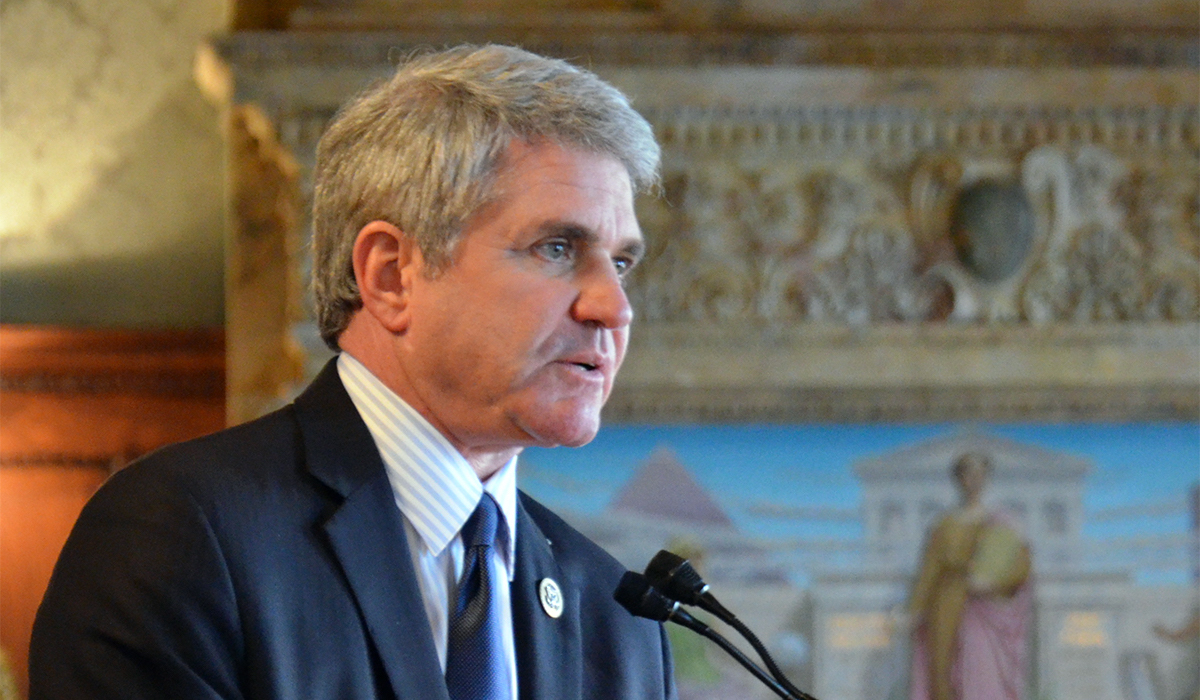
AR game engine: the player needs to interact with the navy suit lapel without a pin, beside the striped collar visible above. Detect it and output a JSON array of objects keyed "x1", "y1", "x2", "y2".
[{"x1": 295, "y1": 361, "x2": 449, "y2": 700}]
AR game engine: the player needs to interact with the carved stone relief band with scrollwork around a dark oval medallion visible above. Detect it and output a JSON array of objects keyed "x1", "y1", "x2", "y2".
[{"x1": 631, "y1": 112, "x2": 1200, "y2": 325}]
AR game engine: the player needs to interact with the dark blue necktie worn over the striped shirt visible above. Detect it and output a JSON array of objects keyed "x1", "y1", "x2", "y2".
[{"x1": 446, "y1": 492, "x2": 508, "y2": 700}]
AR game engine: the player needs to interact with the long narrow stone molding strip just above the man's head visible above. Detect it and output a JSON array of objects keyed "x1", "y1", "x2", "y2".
[{"x1": 215, "y1": 26, "x2": 1200, "y2": 73}]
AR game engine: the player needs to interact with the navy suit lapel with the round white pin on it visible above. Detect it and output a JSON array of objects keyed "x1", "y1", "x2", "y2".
[{"x1": 512, "y1": 498, "x2": 583, "y2": 700}]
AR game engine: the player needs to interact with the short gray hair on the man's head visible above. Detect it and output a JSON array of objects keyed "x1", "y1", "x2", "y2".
[{"x1": 312, "y1": 46, "x2": 660, "y2": 349}]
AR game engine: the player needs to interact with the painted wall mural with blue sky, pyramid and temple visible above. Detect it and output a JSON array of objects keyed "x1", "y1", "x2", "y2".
[{"x1": 521, "y1": 423, "x2": 1200, "y2": 700}]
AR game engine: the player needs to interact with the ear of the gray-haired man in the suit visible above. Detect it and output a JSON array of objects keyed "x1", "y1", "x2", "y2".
[{"x1": 354, "y1": 221, "x2": 421, "y2": 333}]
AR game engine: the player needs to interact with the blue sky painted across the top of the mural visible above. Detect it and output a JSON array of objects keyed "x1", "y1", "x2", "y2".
[{"x1": 521, "y1": 423, "x2": 1200, "y2": 585}]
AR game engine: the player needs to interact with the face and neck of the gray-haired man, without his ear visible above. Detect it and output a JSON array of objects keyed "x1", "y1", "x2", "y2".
[{"x1": 400, "y1": 142, "x2": 643, "y2": 450}]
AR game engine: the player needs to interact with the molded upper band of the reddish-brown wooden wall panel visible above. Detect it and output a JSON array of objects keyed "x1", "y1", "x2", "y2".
[{"x1": 0, "y1": 325, "x2": 226, "y2": 469}]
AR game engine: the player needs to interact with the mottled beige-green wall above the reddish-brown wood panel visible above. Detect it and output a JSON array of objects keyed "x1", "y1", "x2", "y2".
[{"x1": 0, "y1": 0, "x2": 227, "y2": 327}]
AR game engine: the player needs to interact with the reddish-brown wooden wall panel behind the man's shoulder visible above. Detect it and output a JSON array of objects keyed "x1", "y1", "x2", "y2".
[{"x1": 0, "y1": 325, "x2": 224, "y2": 694}]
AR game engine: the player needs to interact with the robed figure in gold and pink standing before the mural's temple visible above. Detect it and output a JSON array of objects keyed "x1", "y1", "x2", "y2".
[{"x1": 907, "y1": 453, "x2": 1032, "y2": 700}]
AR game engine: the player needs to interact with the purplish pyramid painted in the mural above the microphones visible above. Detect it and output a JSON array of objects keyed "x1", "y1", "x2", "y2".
[{"x1": 608, "y1": 447, "x2": 733, "y2": 528}]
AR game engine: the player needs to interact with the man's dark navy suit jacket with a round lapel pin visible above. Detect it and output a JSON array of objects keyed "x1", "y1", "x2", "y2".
[{"x1": 30, "y1": 363, "x2": 674, "y2": 700}]
